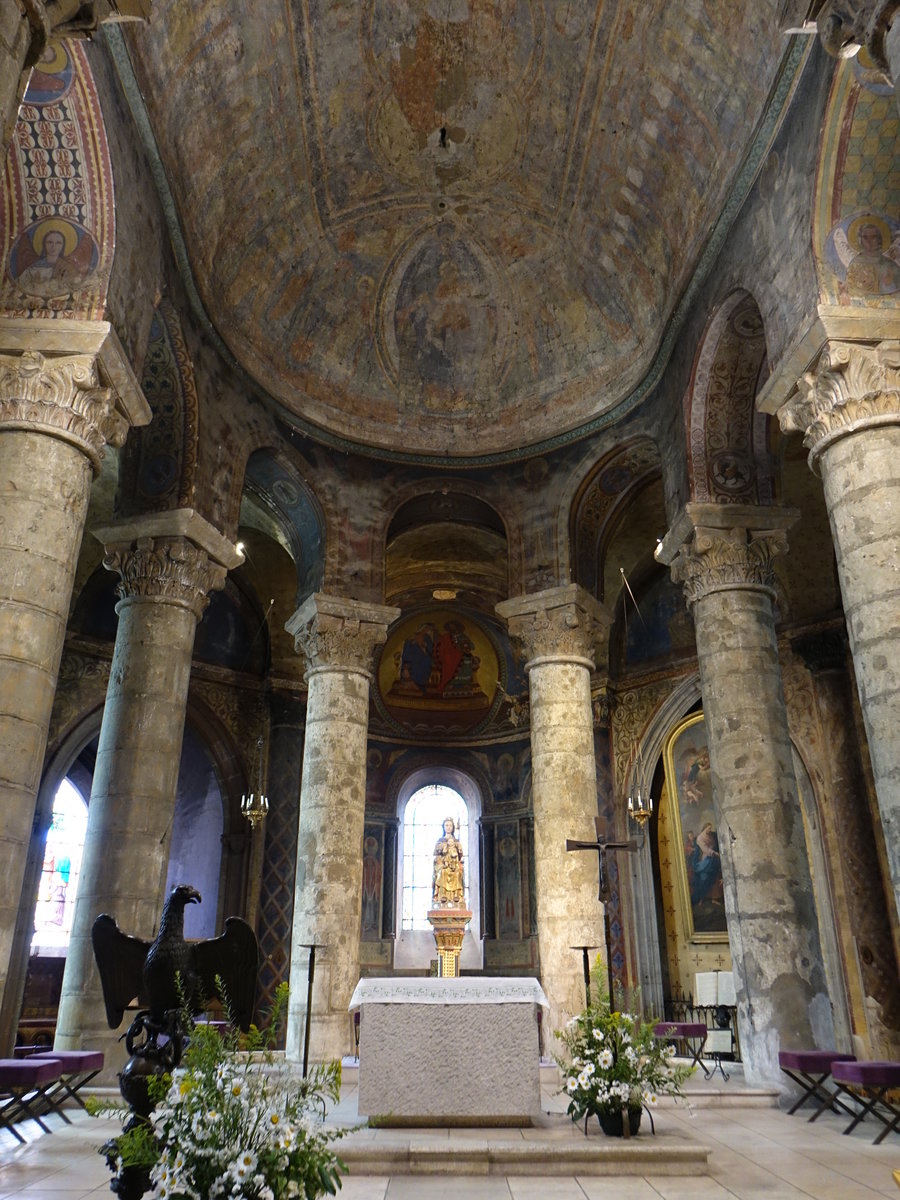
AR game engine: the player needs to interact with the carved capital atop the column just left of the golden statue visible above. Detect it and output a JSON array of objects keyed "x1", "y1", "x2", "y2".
[{"x1": 284, "y1": 592, "x2": 401, "y2": 678}]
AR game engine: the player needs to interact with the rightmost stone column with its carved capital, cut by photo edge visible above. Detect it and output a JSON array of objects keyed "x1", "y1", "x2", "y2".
[{"x1": 778, "y1": 341, "x2": 900, "y2": 931}]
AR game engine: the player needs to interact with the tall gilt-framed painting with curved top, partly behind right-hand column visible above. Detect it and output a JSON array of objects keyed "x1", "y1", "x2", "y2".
[{"x1": 665, "y1": 713, "x2": 728, "y2": 942}]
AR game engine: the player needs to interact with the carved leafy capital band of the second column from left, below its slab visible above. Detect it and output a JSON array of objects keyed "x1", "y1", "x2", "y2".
[{"x1": 103, "y1": 538, "x2": 227, "y2": 620}]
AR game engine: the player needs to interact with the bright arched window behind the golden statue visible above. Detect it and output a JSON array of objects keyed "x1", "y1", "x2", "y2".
[{"x1": 401, "y1": 784, "x2": 473, "y2": 929}]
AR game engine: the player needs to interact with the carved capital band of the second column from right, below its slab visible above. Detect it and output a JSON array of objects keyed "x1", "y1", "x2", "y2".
[{"x1": 671, "y1": 526, "x2": 787, "y2": 605}]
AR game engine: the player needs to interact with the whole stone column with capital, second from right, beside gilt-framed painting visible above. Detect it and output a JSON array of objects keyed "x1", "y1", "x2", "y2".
[{"x1": 656, "y1": 504, "x2": 834, "y2": 1086}]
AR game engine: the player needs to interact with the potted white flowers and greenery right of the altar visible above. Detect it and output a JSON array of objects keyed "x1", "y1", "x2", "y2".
[{"x1": 557, "y1": 974, "x2": 694, "y2": 1138}]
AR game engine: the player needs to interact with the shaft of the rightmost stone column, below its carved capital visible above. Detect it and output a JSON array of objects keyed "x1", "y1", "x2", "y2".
[{"x1": 820, "y1": 424, "x2": 900, "y2": 916}]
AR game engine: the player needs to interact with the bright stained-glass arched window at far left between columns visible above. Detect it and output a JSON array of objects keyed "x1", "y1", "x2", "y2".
[{"x1": 31, "y1": 779, "x2": 88, "y2": 954}]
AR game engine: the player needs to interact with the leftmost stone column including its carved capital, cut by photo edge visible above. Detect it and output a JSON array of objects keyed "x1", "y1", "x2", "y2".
[{"x1": 0, "y1": 322, "x2": 150, "y2": 1050}]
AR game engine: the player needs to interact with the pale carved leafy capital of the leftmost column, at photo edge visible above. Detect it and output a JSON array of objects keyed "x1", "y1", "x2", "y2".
[{"x1": 0, "y1": 352, "x2": 128, "y2": 473}]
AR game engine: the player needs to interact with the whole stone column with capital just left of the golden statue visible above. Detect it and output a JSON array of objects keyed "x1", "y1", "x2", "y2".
[{"x1": 286, "y1": 593, "x2": 400, "y2": 1062}]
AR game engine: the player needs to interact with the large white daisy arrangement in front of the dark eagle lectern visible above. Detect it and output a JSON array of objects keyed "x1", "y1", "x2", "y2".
[{"x1": 95, "y1": 988, "x2": 344, "y2": 1200}]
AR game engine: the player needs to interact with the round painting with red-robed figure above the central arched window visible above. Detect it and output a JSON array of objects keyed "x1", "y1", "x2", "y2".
[{"x1": 376, "y1": 608, "x2": 503, "y2": 733}]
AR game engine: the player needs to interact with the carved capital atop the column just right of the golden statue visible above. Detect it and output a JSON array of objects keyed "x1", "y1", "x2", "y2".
[{"x1": 496, "y1": 583, "x2": 611, "y2": 670}]
